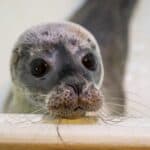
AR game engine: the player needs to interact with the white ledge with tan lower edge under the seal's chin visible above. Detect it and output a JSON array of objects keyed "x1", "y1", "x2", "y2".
[{"x1": 0, "y1": 114, "x2": 150, "y2": 150}]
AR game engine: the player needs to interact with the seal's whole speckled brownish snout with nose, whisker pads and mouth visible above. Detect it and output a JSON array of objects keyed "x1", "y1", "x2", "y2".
[{"x1": 48, "y1": 81, "x2": 103, "y2": 118}]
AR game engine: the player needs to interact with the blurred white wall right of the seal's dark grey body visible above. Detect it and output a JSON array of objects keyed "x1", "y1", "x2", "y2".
[{"x1": 125, "y1": 0, "x2": 150, "y2": 117}]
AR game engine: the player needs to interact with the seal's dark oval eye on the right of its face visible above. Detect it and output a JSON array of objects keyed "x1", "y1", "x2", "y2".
[{"x1": 82, "y1": 53, "x2": 97, "y2": 71}]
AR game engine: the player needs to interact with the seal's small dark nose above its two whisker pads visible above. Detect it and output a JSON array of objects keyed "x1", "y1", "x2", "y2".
[{"x1": 68, "y1": 81, "x2": 84, "y2": 95}]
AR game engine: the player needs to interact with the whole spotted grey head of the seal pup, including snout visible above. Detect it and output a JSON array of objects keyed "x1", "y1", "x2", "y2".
[{"x1": 11, "y1": 23, "x2": 103, "y2": 118}]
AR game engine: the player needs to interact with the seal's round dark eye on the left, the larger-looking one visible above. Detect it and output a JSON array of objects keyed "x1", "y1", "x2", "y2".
[{"x1": 30, "y1": 58, "x2": 49, "y2": 77}]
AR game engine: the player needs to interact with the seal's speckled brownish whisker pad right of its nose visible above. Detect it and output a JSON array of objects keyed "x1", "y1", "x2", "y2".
[{"x1": 79, "y1": 86, "x2": 104, "y2": 111}]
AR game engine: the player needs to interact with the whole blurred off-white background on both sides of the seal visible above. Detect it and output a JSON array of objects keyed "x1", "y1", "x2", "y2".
[{"x1": 0, "y1": 0, "x2": 150, "y2": 116}]
